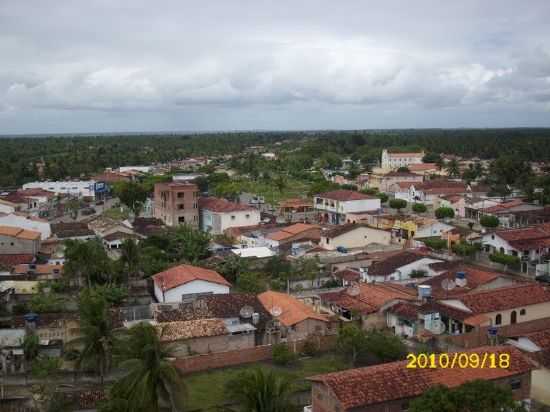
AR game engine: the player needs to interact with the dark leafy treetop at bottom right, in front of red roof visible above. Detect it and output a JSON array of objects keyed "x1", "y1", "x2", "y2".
[{"x1": 409, "y1": 380, "x2": 525, "y2": 412}]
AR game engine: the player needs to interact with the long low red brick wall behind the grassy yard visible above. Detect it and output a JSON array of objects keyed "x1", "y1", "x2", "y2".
[{"x1": 174, "y1": 336, "x2": 336, "y2": 373}]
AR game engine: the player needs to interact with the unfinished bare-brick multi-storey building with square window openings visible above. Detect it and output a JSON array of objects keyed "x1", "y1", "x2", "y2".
[{"x1": 153, "y1": 182, "x2": 199, "y2": 228}]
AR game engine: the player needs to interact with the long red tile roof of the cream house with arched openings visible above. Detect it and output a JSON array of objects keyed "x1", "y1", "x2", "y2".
[{"x1": 440, "y1": 283, "x2": 550, "y2": 315}]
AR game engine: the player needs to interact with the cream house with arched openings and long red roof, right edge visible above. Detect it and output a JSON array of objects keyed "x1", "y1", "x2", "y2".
[{"x1": 433, "y1": 282, "x2": 550, "y2": 334}]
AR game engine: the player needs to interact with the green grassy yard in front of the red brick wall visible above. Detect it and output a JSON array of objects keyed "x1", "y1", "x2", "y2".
[{"x1": 185, "y1": 353, "x2": 351, "y2": 411}]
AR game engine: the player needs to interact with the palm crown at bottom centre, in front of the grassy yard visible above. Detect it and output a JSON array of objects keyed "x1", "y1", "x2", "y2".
[{"x1": 227, "y1": 368, "x2": 295, "y2": 412}]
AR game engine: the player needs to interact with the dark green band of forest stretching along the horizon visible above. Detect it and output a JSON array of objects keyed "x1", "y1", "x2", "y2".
[{"x1": 0, "y1": 128, "x2": 550, "y2": 187}]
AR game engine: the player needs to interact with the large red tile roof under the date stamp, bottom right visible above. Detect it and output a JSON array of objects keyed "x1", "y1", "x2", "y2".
[{"x1": 309, "y1": 346, "x2": 533, "y2": 410}]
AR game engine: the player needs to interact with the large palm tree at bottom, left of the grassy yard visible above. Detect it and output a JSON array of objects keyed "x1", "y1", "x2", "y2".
[{"x1": 111, "y1": 323, "x2": 186, "y2": 412}]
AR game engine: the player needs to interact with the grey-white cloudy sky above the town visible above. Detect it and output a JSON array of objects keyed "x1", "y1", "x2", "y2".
[{"x1": 0, "y1": 0, "x2": 550, "y2": 134}]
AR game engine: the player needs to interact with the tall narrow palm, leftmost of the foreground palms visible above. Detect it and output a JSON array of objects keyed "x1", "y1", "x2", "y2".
[{"x1": 71, "y1": 289, "x2": 115, "y2": 384}]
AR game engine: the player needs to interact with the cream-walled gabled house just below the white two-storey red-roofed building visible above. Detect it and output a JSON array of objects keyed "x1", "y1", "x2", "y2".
[{"x1": 319, "y1": 223, "x2": 392, "y2": 250}]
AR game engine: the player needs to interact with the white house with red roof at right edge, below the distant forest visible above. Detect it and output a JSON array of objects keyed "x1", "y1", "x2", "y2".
[{"x1": 481, "y1": 223, "x2": 550, "y2": 272}]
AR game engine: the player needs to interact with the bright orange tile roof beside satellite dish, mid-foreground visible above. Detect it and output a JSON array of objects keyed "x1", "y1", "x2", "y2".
[{"x1": 258, "y1": 291, "x2": 329, "y2": 326}]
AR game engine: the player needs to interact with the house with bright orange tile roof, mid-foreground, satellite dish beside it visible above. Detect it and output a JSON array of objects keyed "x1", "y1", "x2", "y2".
[{"x1": 258, "y1": 291, "x2": 334, "y2": 343}]
